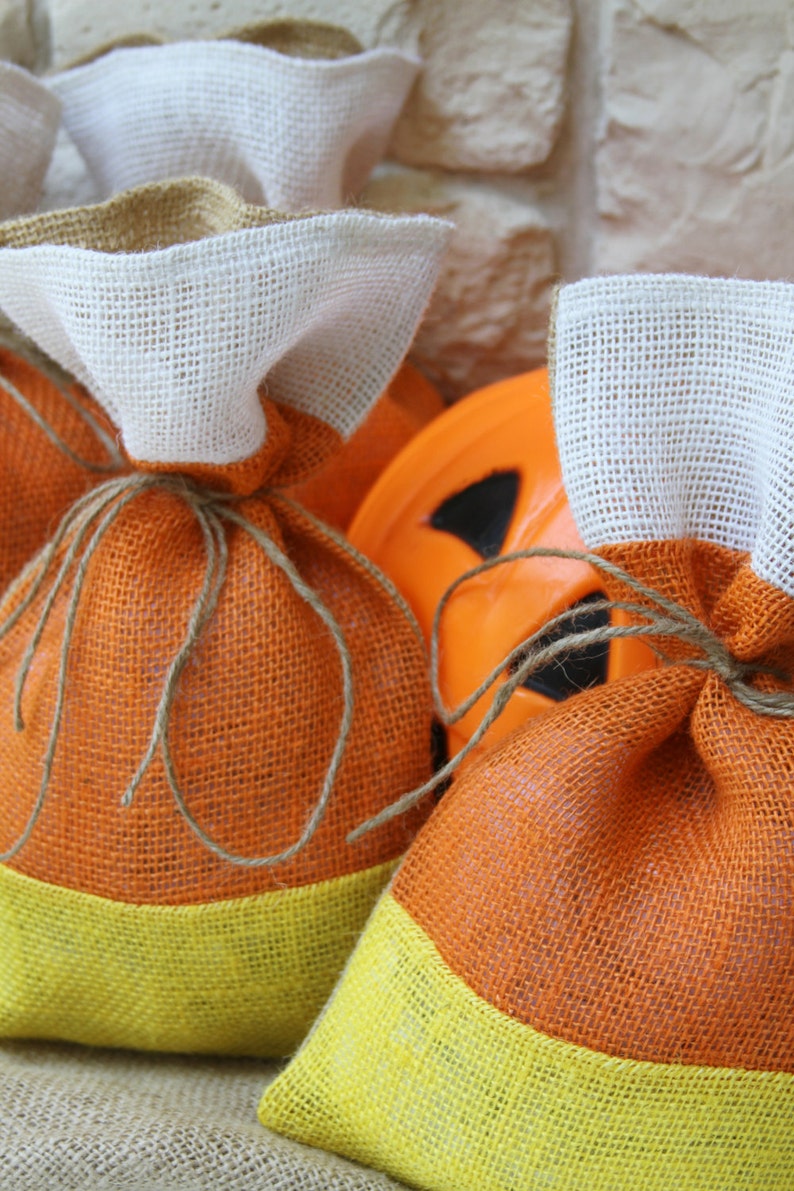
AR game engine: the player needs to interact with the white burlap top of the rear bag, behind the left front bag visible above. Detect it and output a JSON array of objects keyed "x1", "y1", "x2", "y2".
[{"x1": 49, "y1": 42, "x2": 419, "y2": 211}]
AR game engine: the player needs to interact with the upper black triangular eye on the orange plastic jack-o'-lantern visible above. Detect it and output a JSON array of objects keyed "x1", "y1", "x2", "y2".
[{"x1": 430, "y1": 472, "x2": 520, "y2": 559}]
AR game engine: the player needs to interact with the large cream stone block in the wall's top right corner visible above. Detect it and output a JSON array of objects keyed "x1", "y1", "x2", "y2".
[{"x1": 593, "y1": 0, "x2": 794, "y2": 278}]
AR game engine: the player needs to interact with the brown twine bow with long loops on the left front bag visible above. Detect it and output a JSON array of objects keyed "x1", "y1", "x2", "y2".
[{"x1": 0, "y1": 474, "x2": 424, "y2": 868}]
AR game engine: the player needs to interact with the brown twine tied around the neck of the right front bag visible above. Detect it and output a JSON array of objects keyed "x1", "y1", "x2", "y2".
[{"x1": 348, "y1": 545, "x2": 794, "y2": 843}]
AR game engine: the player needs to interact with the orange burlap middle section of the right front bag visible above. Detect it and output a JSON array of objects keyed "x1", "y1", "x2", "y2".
[{"x1": 393, "y1": 541, "x2": 794, "y2": 1072}]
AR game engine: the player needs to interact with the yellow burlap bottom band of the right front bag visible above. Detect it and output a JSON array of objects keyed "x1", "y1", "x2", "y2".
[{"x1": 260, "y1": 894, "x2": 794, "y2": 1191}]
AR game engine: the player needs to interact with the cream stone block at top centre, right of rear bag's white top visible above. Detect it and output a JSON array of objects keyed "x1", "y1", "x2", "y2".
[{"x1": 393, "y1": 0, "x2": 571, "y2": 174}]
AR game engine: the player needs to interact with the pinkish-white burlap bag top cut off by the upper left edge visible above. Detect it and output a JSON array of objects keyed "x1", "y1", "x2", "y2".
[{"x1": 0, "y1": 62, "x2": 61, "y2": 219}]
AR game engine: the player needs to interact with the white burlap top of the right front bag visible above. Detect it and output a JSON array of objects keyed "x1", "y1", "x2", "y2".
[{"x1": 554, "y1": 275, "x2": 794, "y2": 596}]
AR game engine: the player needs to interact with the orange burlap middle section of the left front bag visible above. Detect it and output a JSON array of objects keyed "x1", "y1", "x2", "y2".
[{"x1": 0, "y1": 403, "x2": 431, "y2": 905}]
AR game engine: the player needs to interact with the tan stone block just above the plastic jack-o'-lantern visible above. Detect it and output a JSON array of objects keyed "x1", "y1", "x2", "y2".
[{"x1": 362, "y1": 168, "x2": 556, "y2": 398}]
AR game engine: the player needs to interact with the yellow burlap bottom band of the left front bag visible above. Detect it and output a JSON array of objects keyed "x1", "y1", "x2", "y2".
[{"x1": 0, "y1": 862, "x2": 394, "y2": 1056}]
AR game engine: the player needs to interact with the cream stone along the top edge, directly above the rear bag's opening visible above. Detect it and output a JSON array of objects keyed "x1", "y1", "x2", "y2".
[{"x1": 49, "y1": 0, "x2": 415, "y2": 69}]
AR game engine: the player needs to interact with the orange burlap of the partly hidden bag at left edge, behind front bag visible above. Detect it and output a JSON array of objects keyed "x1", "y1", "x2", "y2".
[{"x1": 0, "y1": 348, "x2": 121, "y2": 592}]
